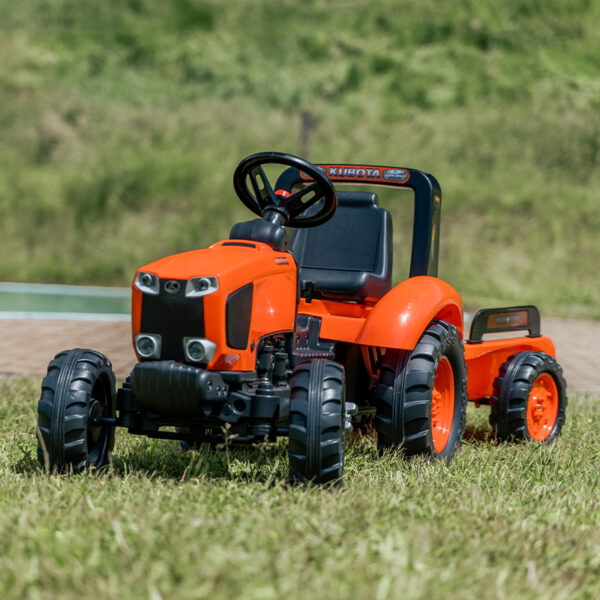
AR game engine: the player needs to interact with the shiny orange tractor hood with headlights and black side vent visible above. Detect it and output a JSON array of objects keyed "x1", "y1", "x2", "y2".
[{"x1": 132, "y1": 240, "x2": 297, "y2": 371}]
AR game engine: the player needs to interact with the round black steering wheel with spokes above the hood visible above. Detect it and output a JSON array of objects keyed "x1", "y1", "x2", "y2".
[{"x1": 233, "y1": 152, "x2": 337, "y2": 227}]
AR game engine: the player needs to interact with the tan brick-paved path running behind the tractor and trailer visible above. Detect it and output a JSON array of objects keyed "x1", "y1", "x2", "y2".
[{"x1": 0, "y1": 317, "x2": 600, "y2": 396}]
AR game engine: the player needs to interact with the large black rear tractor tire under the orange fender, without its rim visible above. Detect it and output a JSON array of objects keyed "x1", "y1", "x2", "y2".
[{"x1": 375, "y1": 321, "x2": 467, "y2": 458}]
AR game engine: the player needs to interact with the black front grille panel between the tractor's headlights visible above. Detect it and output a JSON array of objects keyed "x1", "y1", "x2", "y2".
[{"x1": 141, "y1": 279, "x2": 205, "y2": 361}]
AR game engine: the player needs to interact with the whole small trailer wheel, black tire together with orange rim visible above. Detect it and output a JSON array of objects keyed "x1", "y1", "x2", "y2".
[{"x1": 490, "y1": 351, "x2": 567, "y2": 442}]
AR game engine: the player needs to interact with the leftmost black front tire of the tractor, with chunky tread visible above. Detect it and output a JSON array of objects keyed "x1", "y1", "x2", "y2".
[{"x1": 38, "y1": 348, "x2": 116, "y2": 472}]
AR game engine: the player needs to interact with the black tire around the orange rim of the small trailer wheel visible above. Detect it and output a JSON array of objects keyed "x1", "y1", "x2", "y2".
[{"x1": 490, "y1": 351, "x2": 567, "y2": 443}]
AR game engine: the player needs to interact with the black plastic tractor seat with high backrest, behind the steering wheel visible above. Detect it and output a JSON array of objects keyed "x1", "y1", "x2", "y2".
[{"x1": 292, "y1": 192, "x2": 392, "y2": 302}]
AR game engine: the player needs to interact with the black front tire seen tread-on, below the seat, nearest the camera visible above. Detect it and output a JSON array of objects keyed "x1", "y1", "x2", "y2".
[{"x1": 288, "y1": 358, "x2": 345, "y2": 483}]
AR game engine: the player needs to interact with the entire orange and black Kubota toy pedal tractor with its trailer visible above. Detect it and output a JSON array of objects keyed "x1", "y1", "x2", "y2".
[{"x1": 38, "y1": 152, "x2": 566, "y2": 483}]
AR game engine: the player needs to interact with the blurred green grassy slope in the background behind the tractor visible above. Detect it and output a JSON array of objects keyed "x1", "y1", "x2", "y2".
[{"x1": 0, "y1": 0, "x2": 600, "y2": 318}]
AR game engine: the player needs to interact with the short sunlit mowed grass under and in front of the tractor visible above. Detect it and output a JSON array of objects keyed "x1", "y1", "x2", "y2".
[{"x1": 0, "y1": 378, "x2": 600, "y2": 600}]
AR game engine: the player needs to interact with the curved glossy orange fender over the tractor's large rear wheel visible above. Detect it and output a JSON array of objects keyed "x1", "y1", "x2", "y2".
[{"x1": 357, "y1": 275, "x2": 463, "y2": 350}]
